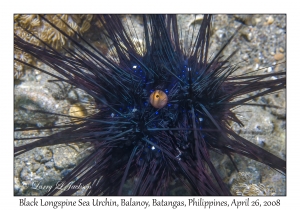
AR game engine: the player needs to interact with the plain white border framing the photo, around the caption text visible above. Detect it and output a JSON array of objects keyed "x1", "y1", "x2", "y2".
[{"x1": 0, "y1": 0, "x2": 300, "y2": 209}]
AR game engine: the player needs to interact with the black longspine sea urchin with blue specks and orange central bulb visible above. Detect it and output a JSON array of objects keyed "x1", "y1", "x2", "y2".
[{"x1": 14, "y1": 15, "x2": 286, "y2": 195}]
